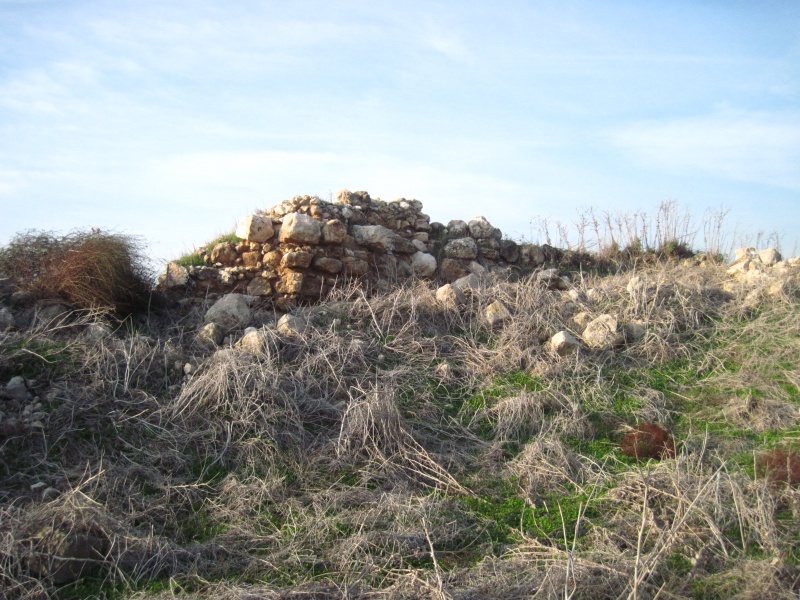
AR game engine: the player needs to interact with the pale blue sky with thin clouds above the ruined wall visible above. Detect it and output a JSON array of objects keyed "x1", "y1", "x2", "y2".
[{"x1": 0, "y1": 0, "x2": 800, "y2": 261}]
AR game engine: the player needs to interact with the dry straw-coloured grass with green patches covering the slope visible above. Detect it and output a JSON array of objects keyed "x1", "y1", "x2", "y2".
[{"x1": 0, "y1": 223, "x2": 800, "y2": 600}]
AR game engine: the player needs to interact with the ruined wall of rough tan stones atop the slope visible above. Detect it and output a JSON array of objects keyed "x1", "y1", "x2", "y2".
[{"x1": 161, "y1": 190, "x2": 555, "y2": 305}]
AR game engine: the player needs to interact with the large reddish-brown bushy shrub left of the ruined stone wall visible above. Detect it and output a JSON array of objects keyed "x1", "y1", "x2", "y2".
[{"x1": 0, "y1": 230, "x2": 152, "y2": 316}]
